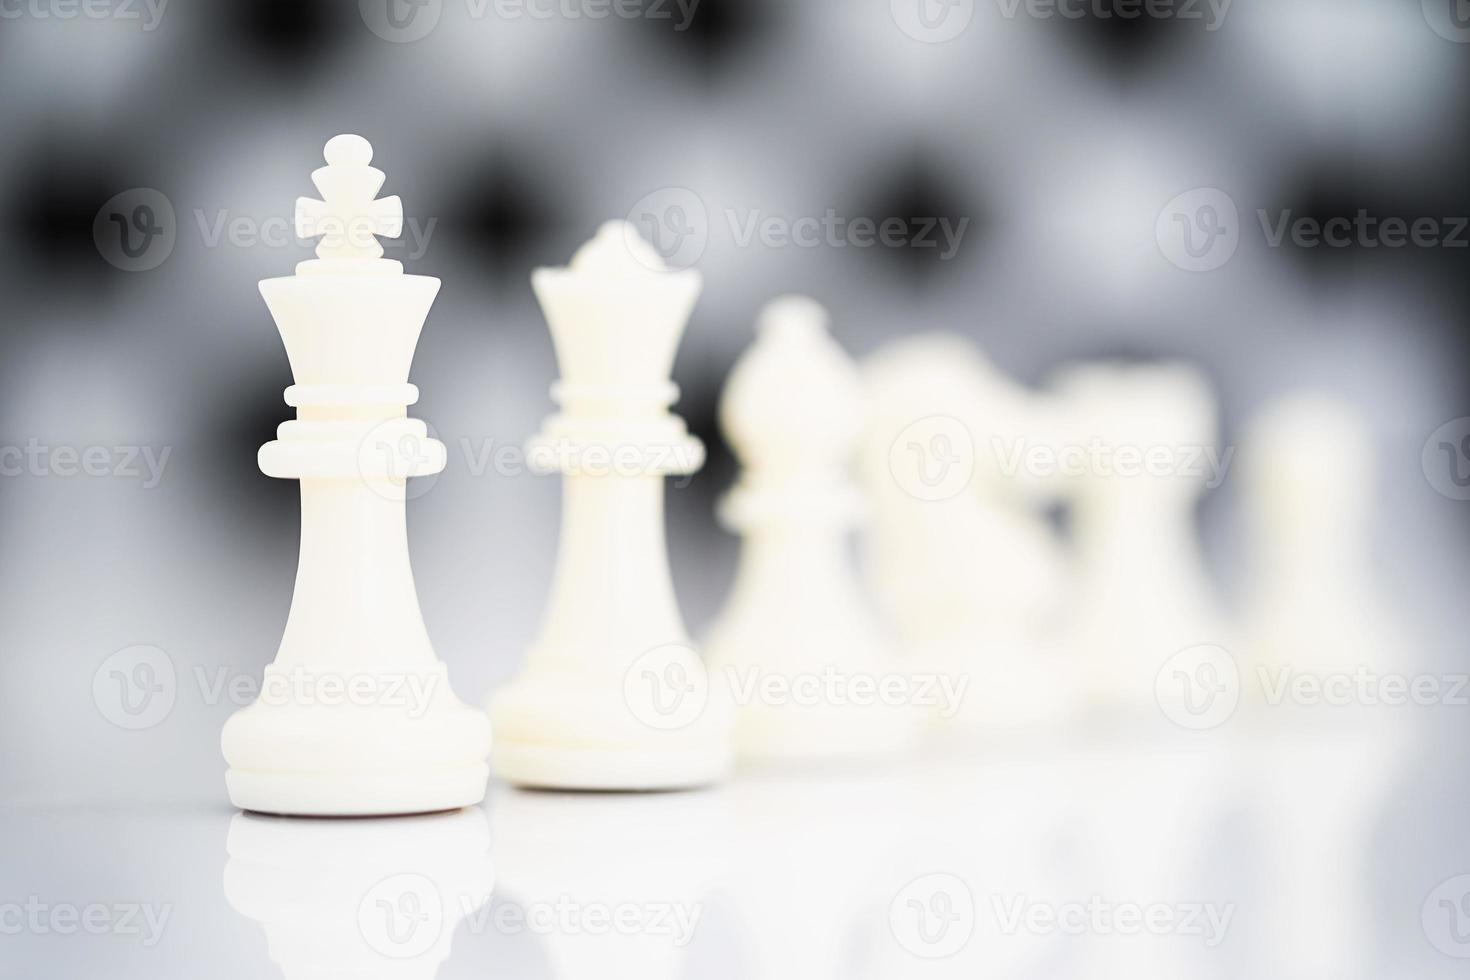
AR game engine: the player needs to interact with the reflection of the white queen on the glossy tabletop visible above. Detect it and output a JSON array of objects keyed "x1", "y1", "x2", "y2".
[{"x1": 491, "y1": 789, "x2": 732, "y2": 980}]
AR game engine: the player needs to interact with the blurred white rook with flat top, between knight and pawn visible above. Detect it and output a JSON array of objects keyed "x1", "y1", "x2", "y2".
[{"x1": 1054, "y1": 363, "x2": 1236, "y2": 721}]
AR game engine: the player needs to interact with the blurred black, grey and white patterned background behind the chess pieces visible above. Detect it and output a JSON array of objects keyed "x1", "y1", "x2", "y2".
[{"x1": 0, "y1": 0, "x2": 1470, "y2": 963}]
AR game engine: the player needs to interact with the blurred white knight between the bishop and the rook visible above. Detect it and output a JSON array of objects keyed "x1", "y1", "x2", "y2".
[{"x1": 863, "y1": 334, "x2": 1075, "y2": 735}]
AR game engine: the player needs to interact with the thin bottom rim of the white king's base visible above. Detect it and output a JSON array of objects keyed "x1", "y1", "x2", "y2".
[{"x1": 225, "y1": 763, "x2": 490, "y2": 817}]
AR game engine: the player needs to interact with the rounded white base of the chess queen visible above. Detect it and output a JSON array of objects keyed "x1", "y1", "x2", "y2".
[{"x1": 490, "y1": 679, "x2": 734, "y2": 792}]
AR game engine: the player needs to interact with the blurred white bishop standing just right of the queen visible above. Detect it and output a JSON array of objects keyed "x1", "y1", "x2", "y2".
[{"x1": 706, "y1": 297, "x2": 922, "y2": 761}]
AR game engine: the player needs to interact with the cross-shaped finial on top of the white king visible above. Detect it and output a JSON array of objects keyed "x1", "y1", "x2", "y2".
[{"x1": 295, "y1": 134, "x2": 403, "y2": 272}]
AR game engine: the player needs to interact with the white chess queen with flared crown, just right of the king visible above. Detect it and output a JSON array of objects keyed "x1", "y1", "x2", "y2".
[{"x1": 491, "y1": 222, "x2": 731, "y2": 790}]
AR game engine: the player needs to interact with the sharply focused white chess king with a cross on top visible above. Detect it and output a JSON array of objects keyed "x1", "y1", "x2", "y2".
[{"x1": 222, "y1": 135, "x2": 490, "y2": 815}]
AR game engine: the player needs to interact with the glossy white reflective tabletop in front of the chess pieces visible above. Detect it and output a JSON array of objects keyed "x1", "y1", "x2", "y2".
[{"x1": 0, "y1": 723, "x2": 1434, "y2": 980}]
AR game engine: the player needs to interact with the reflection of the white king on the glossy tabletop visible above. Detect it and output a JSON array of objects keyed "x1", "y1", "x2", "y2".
[{"x1": 225, "y1": 810, "x2": 495, "y2": 980}]
